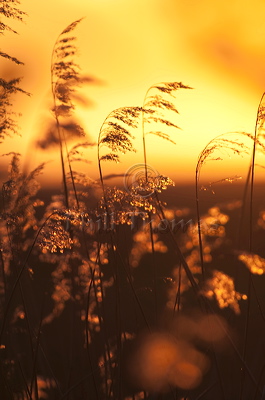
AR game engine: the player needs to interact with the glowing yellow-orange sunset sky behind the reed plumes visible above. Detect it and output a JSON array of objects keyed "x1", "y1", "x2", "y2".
[{"x1": 2, "y1": 0, "x2": 265, "y2": 188}]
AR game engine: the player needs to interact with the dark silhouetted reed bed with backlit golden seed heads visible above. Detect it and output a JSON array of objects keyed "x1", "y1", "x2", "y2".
[{"x1": 0, "y1": 0, "x2": 265, "y2": 400}]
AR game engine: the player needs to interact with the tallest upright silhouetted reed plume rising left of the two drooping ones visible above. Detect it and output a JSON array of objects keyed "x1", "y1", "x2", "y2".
[{"x1": 51, "y1": 19, "x2": 98, "y2": 208}]
